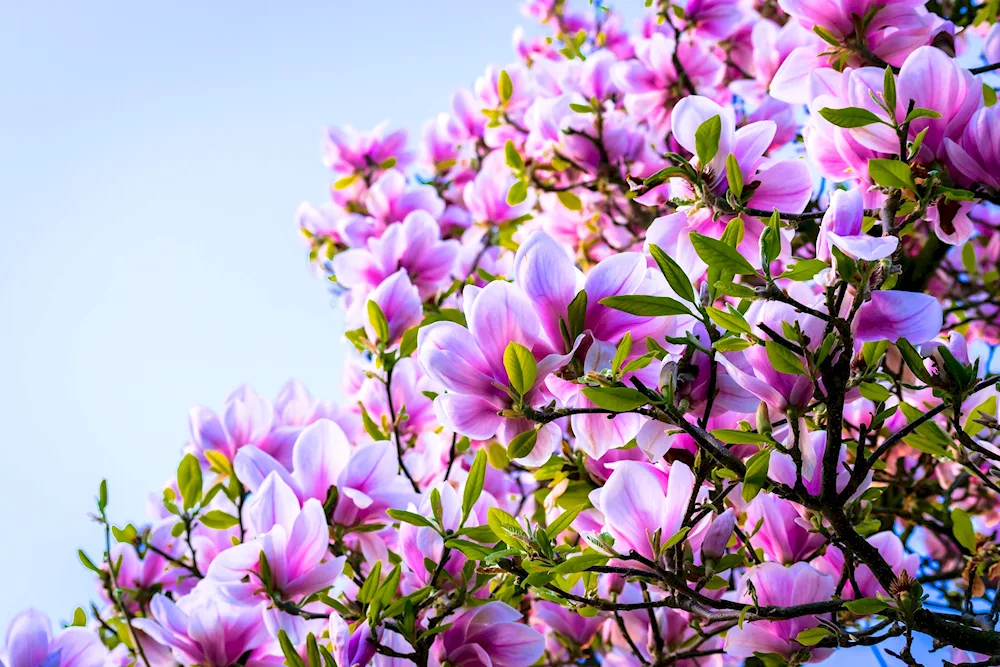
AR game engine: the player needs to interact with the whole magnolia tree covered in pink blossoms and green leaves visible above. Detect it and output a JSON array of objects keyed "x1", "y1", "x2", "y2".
[{"x1": 3, "y1": 0, "x2": 1000, "y2": 667}]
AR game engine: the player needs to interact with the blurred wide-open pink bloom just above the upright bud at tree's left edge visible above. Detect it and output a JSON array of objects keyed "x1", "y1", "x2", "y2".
[{"x1": 333, "y1": 211, "x2": 458, "y2": 297}]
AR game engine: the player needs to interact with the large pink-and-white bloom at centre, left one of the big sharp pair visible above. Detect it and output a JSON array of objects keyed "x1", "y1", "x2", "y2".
[{"x1": 417, "y1": 280, "x2": 572, "y2": 440}]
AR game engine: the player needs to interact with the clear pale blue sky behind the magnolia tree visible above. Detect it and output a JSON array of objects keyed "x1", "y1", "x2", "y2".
[{"x1": 0, "y1": 0, "x2": 952, "y2": 665}]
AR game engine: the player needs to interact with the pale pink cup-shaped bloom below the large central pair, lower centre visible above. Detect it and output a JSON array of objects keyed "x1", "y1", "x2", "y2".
[{"x1": 591, "y1": 461, "x2": 695, "y2": 560}]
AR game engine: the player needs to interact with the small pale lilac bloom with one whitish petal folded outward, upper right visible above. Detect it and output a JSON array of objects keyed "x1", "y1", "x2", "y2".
[{"x1": 816, "y1": 189, "x2": 899, "y2": 261}]
